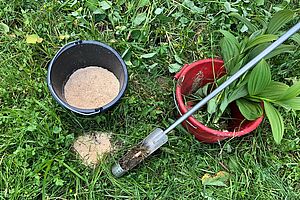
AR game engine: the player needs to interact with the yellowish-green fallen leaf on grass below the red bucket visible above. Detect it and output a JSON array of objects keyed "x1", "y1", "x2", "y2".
[{"x1": 201, "y1": 171, "x2": 230, "y2": 186}]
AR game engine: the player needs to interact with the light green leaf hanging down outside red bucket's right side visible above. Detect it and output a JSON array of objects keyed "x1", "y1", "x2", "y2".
[{"x1": 264, "y1": 101, "x2": 284, "y2": 144}]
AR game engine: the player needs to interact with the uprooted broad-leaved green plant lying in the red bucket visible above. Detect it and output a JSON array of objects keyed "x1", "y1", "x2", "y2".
[{"x1": 193, "y1": 10, "x2": 300, "y2": 144}]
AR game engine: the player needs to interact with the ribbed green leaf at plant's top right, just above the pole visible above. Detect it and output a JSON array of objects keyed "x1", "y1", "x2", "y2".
[{"x1": 267, "y1": 10, "x2": 294, "y2": 34}]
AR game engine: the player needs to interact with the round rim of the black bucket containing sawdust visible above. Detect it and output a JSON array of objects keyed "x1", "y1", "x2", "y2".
[{"x1": 47, "y1": 40, "x2": 128, "y2": 116}]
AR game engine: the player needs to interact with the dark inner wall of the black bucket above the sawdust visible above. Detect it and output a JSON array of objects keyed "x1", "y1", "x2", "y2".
[{"x1": 50, "y1": 42, "x2": 126, "y2": 101}]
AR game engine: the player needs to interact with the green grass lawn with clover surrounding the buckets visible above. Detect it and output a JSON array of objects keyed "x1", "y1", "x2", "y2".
[{"x1": 0, "y1": 0, "x2": 300, "y2": 199}]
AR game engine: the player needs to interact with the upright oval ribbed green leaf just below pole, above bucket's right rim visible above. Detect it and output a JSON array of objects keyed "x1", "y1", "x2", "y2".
[{"x1": 248, "y1": 60, "x2": 271, "y2": 96}]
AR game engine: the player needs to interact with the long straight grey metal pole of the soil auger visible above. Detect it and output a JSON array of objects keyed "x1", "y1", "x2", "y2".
[{"x1": 164, "y1": 22, "x2": 300, "y2": 134}]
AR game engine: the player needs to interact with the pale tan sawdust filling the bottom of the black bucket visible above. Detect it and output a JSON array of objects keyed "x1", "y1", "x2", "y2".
[{"x1": 64, "y1": 66, "x2": 120, "y2": 109}]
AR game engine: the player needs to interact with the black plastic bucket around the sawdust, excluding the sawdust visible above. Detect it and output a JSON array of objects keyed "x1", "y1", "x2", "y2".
[{"x1": 47, "y1": 41, "x2": 128, "y2": 115}]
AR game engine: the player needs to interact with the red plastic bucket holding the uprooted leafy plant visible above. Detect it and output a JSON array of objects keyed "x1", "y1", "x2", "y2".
[{"x1": 175, "y1": 59, "x2": 263, "y2": 143}]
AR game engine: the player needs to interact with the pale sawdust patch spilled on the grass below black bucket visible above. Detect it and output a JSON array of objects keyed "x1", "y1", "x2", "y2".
[{"x1": 73, "y1": 132, "x2": 112, "y2": 167}]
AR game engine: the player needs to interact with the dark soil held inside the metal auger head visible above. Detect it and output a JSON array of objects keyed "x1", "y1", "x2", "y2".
[{"x1": 119, "y1": 146, "x2": 148, "y2": 170}]
